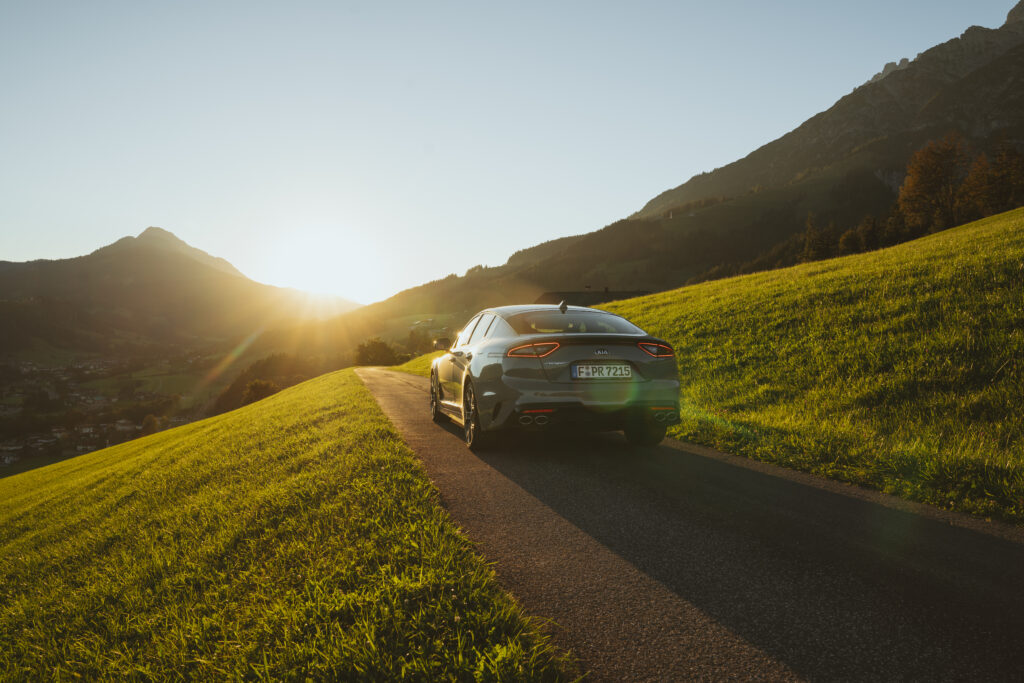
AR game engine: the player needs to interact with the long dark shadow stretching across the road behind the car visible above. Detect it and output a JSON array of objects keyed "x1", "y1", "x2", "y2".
[{"x1": 473, "y1": 432, "x2": 1024, "y2": 680}]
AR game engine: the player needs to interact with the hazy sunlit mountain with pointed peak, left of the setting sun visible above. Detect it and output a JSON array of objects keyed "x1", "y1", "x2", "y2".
[{"x1": 0, "y1": 227, "x2": 357, "y2": 353}]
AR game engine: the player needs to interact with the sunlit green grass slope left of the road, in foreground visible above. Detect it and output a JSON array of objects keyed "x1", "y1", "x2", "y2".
[{"x1": 0, "y1": 371, "x2": 571, "y2": 681}]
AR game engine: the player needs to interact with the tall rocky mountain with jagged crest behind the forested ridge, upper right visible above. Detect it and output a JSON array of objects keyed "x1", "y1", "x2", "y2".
[{"x1": 635, "y1": 2, "x2": 1024, "y2": 217}]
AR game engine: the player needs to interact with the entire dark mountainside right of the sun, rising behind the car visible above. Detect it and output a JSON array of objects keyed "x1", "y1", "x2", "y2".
[{"x1": 339, "y1": 2, "x2": 1024, "y2": 325}]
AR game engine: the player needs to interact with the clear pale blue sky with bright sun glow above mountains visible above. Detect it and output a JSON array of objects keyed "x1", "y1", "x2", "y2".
[{"x1": 0, "y1": 0, "x2": 1014, "y2": 303}]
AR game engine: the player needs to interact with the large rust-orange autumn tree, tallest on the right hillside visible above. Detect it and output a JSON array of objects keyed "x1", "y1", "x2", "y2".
[{"x1": 897, "y1": 132, "x2": 967, "y2": 234}]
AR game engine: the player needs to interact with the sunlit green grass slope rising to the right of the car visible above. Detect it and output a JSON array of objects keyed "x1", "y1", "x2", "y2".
[{"x1": 607, "y1": 210, "x2": 1024, "y2": 522}]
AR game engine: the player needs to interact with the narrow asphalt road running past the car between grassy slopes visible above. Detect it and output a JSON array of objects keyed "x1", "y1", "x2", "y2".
[{"x1": 358, "y1": 369, "x2": 1024, "y2": 681}]
